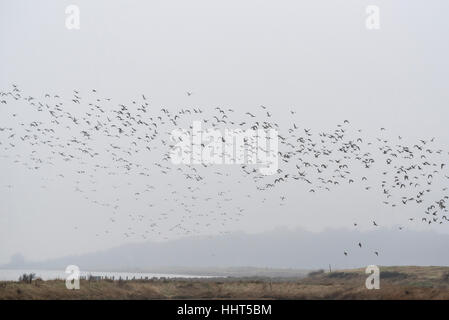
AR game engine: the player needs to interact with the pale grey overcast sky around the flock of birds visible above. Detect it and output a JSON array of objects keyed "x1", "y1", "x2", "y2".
[{"x1": 0, "y1": 0, "x2": 449, "y2": 263}]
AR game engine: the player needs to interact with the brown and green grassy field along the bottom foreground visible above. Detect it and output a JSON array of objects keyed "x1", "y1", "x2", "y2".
[{"x1": 0, "y1": 267, "x2": 449, "y2": 299}]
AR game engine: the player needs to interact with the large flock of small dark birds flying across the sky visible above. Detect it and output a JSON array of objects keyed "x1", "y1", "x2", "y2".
[{"x1": 0, "y1": 85, "x2": 449, "y2": 255}]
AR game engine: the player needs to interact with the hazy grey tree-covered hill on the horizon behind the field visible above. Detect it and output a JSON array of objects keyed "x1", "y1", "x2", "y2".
[{"x1": 2, "y1": 228, "x2": 449, "y2": 275}]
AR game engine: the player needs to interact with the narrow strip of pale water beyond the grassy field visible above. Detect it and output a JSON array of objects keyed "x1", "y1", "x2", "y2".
[{"x1": 0, "y1": 269, "x2": 207, "y2": 281}]
